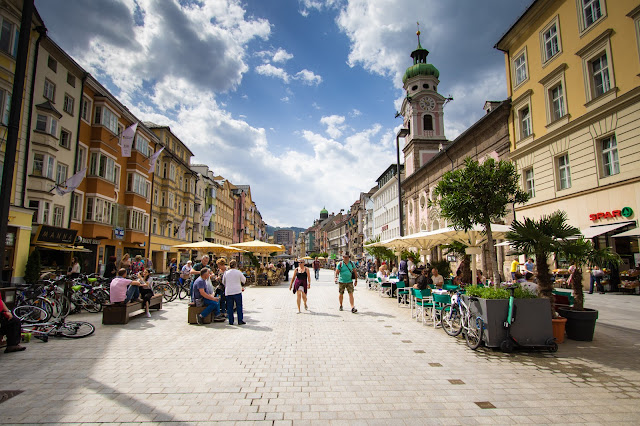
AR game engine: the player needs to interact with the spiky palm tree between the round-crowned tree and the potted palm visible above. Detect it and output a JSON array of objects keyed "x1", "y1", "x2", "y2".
[{"x1": 506, "y1": 211, "x2": 580, "y2": 305}]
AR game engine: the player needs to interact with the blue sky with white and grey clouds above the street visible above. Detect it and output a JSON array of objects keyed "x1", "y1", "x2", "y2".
[{"x1": 36, "y1": 0, "x2": 531, "y2": 228}]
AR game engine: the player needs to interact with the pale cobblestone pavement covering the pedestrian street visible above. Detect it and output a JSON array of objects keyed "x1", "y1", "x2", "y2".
[{"x1": 0, "y1": 270, "x2": 640, "y2": 425}]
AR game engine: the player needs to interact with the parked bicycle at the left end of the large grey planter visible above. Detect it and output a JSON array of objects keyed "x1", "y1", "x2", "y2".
[{"x1": 441, "y1": 290, "x2": 484, "y2": 350}]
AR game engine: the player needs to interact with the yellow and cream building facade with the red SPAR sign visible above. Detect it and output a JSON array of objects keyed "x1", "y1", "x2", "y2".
[{"x1": 496, "y1": 0, "x2": 640, "y2": 269}]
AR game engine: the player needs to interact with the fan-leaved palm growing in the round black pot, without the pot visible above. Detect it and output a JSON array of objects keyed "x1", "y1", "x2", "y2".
[{"x1": 560, "y1": 237, "x2": 622, "y2": 311}]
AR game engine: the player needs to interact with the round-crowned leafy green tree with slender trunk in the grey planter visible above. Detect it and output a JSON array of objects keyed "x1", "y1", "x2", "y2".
[{"x1": 430, "y1": 157, "x2": 529, "y2": 283}]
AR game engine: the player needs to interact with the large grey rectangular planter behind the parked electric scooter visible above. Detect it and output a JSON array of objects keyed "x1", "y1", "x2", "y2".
[{"x1": 463, "y1": 296, "x2": 553, "y2": 348}]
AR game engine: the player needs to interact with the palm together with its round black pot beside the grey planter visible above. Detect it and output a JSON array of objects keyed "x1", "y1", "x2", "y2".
[{"x1": 558, "y1": 237, "x2": 622, "y2": 341}]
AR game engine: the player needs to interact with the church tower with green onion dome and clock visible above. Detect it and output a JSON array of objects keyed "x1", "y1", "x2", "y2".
[{"x1": 400, "y1": 30, "x2": 447, "y2": 176}]
